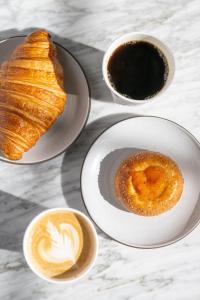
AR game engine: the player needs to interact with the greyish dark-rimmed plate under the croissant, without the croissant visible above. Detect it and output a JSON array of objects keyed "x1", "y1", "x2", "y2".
[{"x1": 0, "y1": 36, "x2": 90, "y2": 164}]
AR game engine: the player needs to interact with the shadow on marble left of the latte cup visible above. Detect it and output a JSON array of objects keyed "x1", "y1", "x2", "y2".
[{"x1": 0, "y1": 191, "x2": 46, "y2": 252}]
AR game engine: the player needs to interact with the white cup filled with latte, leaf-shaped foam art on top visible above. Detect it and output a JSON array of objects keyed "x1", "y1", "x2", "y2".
[{"x1": 24, "y1": 209, "x2": 97, "y2": 282}]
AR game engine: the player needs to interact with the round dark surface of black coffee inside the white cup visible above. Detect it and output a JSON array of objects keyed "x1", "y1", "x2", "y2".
[{"x1": 108, "y1": 41, "x2": 168, "y2": 100}]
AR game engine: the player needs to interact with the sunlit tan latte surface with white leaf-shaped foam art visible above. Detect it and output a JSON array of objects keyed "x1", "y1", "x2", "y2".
[{"x1": 27, "y1": 212, "x2": 83, "y2": 277}]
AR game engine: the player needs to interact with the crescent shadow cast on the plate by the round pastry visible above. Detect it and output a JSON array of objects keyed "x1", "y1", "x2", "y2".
[{"x1": 98, "y1": 147, "x2": 145, "y2": 211}]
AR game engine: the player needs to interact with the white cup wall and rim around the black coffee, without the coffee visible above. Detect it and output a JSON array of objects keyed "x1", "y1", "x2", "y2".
[{"x1": 102, "y1": 32, "x2": 175, "y2": 105}]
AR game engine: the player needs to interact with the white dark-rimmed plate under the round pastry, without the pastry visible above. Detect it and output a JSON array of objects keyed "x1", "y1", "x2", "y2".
[{"x1": 81, "y1": 117, "x2": 200, "y2": 248}]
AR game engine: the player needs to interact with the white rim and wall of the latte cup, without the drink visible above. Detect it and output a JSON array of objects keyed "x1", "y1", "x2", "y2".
[{"x1": 23, "y1": 208, "x2": 98, "y2": 284}]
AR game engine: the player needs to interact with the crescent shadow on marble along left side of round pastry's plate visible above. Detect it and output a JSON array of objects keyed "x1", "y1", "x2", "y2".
[{"x1": 61, "y1": 113, "x2": 139, "y2": 237}]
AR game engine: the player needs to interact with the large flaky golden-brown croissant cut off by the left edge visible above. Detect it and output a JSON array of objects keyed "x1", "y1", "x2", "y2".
[{"x1": 0, "y1": 30, "x2": 66, "y2": 160}]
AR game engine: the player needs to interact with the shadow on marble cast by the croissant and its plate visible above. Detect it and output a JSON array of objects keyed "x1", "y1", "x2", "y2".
[{"x1": 0, "y1": 28, "x2": 113, "y2": 102}]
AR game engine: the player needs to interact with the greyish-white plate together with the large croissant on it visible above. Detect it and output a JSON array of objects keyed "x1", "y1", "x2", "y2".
[{"x1": 0, "y1": 30, "x2": 90, "y2": 164}]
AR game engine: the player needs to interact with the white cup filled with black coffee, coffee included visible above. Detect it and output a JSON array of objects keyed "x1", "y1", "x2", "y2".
[{"x1": 102, "y1": 32, "x2": 175, "y2": 105}]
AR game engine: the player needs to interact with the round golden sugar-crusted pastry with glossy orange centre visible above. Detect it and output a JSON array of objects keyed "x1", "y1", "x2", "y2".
[{"x1": 115, "y1": 151, "x2": 184, "y2": 216}]
